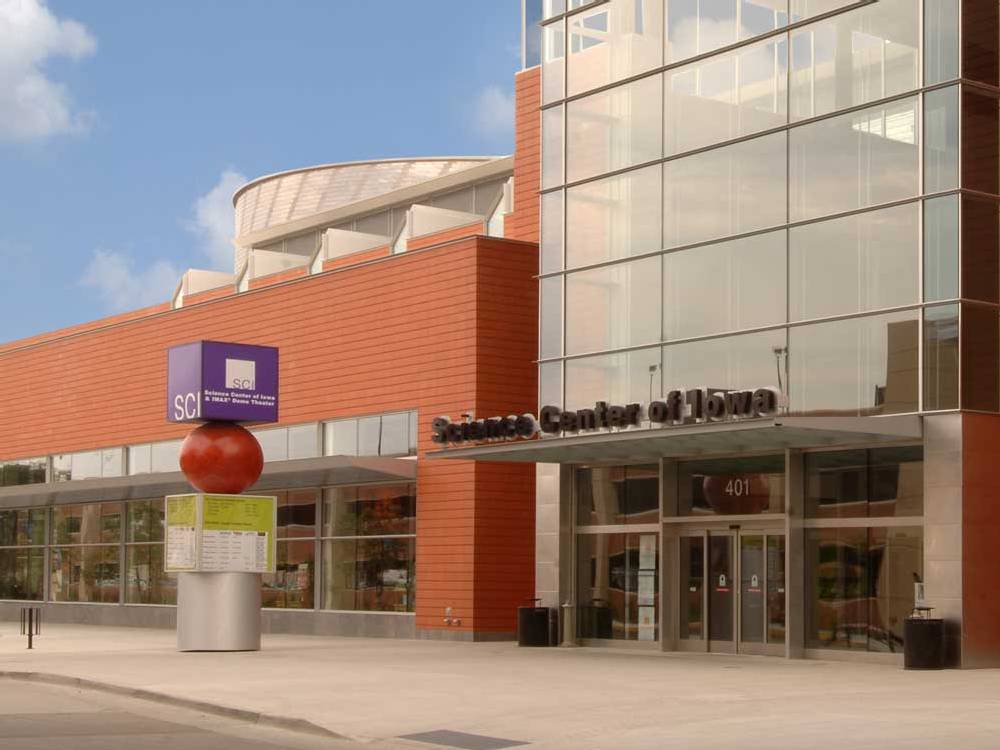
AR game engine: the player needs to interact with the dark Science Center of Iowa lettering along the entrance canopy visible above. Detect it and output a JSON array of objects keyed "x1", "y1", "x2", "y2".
[{"x1": 431, "y1": 388, "x2": 779, "y2": 444}]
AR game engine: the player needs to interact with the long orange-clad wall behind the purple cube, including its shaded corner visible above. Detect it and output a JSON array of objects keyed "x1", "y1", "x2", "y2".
[{"x1": 0, "y1": 237, "x2": 537, "y2": 632}]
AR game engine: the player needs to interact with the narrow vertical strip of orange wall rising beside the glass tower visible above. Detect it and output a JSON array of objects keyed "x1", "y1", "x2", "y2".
[{"x1": 504, "y1": 67, "x2": 542, "y2": 242}]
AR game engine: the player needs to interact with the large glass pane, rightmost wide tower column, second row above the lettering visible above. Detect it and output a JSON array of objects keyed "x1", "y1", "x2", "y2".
[{"x1": 788, "y1": 203, "x2": 920, "y2": 321}]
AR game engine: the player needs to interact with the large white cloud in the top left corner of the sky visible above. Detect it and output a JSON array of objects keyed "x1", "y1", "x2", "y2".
[{"x1": 0, "y1": 0, "x2": 97, "y2": 141}]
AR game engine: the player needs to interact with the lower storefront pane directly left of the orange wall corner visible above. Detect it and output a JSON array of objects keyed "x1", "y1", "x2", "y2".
[{"x1": 323, "y1": 537, "x2": 416, "y2": 612}]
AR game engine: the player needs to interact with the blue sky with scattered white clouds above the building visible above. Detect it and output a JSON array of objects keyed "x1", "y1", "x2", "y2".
[{"x1": 0, "y1": 0, "x2": 520, "y2": 341}]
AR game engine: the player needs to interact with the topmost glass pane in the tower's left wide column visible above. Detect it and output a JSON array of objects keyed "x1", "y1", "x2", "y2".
[{"x1": 566, "y1": 0, "x2": 663, "y2": 96}]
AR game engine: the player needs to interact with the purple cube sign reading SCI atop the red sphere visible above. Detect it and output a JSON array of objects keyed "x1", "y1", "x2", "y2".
[{"x1": 167, "y1": 341, "x2": 278, "y2": 422}]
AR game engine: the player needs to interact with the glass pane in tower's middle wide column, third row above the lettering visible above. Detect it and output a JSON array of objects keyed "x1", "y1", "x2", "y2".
[{"x1": 663, "y1": 133, "x2": 787, "y2": 247}]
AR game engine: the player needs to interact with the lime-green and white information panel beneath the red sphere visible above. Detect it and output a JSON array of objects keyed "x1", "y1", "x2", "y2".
[{"x1": 164, "y1": 494, "x2": 277, "y2": 573}]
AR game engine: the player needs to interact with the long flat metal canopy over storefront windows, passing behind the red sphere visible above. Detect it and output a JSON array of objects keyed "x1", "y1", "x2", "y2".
[{"x1": 0, "y1": 456, "x2": 417, "y2": 508}]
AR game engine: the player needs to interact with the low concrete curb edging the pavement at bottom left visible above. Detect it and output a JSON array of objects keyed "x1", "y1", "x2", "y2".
[{"x1": 0, "y1": 670, "x2": 357, "y2": 741}]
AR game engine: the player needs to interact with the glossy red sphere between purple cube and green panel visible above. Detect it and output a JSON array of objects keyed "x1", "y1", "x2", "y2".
[{"x1": 181, "y1": 422, "x2": 264, "y2": 495}]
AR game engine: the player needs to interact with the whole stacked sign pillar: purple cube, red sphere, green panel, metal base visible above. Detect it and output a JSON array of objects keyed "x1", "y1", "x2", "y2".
[{"x1": 164, "y1": 341, "x2": 278, "y2": 651}]
